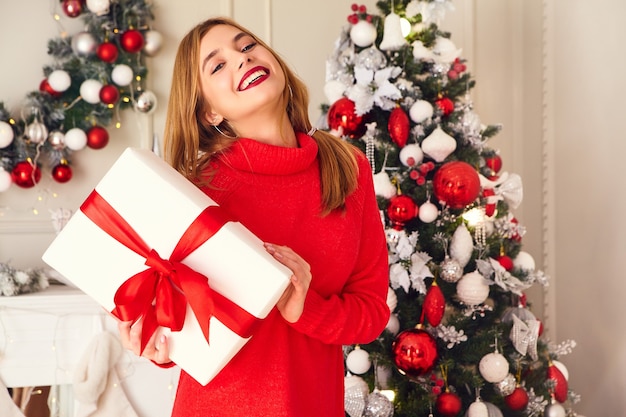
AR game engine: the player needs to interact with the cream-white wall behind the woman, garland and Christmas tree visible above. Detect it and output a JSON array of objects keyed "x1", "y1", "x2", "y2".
[{"x1": 0, "y1": 0, "x2": 626, "y2": 416}]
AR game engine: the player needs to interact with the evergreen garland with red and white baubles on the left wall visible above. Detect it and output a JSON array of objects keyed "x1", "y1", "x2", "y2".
[{"x1": 0, "y1": 0, "x2": 162, "y2": 192}]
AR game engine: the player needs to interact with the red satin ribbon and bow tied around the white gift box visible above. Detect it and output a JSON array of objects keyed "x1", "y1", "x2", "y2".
[{"x1": 80, "y1": 190, "x2": 260, "y2": 352}]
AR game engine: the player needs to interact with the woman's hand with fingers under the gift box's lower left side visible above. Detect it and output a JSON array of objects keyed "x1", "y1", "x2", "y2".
[{"x1": 117, "y1": 319, "x2": 171, "y2": 365}]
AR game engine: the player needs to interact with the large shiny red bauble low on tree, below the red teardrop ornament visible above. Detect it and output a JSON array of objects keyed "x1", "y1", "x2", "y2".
[{"x1": 391, "y1": 329, "x2": 438, "y2": 377}]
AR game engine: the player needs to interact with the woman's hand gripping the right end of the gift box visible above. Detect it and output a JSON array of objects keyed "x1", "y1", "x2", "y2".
[{"x1": 265, "y1": 243, "x2": 311, "y2": 323}]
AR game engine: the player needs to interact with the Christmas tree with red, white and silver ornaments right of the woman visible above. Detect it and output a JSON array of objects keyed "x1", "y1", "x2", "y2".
[{"x1": 322, "y1": 0, "x2": 578, "y2": 417}]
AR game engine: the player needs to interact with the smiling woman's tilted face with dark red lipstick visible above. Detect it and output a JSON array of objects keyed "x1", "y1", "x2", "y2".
[{"x1": 200, "y1": 25, "x2": 285, "y2": 131}]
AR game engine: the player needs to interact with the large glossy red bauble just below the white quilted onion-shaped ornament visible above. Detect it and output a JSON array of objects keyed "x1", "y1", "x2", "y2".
[{"x1": 433, "y1": 161, "x2": 480, "y2": 209}]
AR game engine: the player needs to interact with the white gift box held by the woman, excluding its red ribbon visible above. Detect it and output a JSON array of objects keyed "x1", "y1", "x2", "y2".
[{"x1": 42, "y1": 148, "x2": 291, "y2": 385}]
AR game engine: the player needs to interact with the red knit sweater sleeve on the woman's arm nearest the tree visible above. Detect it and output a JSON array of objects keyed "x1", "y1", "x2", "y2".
[{"x1": 292, "y1": 158, "x2": 390, "y2": 345}]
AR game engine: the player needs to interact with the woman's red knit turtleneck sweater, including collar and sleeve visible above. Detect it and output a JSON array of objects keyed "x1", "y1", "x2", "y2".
[{"x1": 168, "y1": 133, "x2": 389, "y2": 417}]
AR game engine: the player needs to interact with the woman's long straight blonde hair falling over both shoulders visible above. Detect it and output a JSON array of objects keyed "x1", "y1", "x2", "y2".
[{"x1": 164, "y1": 17, "x2": 358, "y2": 214}]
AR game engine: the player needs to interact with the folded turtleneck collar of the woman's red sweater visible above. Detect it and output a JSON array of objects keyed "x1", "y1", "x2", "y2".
[{"x1": 219, "y1": 132, "x2": 318, "y2": 175}]
